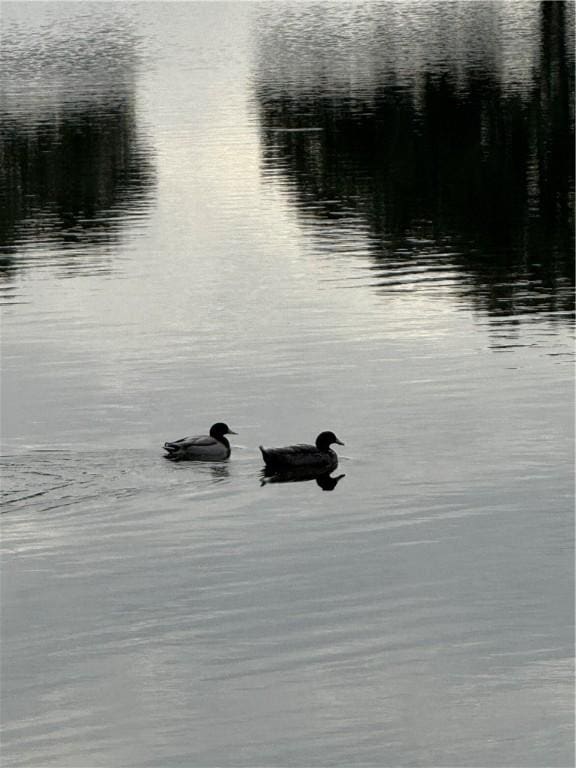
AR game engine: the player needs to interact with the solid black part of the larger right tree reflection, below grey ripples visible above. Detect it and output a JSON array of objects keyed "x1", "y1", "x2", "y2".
[{"x1": 257, "y1": 2, "x2": 574, "y2": 317}]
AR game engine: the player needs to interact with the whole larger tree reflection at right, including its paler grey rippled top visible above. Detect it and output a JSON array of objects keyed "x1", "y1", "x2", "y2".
[{"x1": 254, "y1": 2, "x2": 575, "y2": 322}]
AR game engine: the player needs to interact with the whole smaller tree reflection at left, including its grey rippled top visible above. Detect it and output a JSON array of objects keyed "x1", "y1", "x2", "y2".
[{"x1": 0, "y1": 13, "x2": 154, "y2": 277}]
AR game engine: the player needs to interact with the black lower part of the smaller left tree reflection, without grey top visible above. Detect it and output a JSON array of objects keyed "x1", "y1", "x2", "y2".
[{"x1": 0, "y1": 103, "x2": 151, "y2": 258}]
